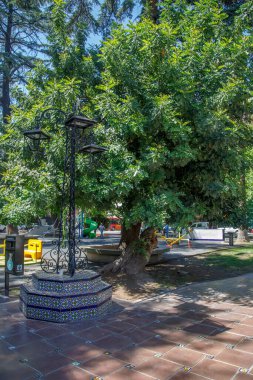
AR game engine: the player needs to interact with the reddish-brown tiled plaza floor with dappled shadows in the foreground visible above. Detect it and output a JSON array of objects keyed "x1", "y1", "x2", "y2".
[{"x1": 0, "y1": 276, "x2": 253, "y2": 380}]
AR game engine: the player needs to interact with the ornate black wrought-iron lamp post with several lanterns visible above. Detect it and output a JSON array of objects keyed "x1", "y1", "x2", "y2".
[{"x1": 24, "y1": 108, "x2": 106, "y2": 277}]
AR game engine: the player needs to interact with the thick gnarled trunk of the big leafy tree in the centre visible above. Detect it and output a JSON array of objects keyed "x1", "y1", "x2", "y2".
[{"x1": 101, "y1": 223, "x2": 157, "y2": 275}]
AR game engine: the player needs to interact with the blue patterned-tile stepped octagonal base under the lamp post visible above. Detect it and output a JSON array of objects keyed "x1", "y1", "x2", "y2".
[{"x1": 20, "y1": 271, "x2": 112, "y2": 323}]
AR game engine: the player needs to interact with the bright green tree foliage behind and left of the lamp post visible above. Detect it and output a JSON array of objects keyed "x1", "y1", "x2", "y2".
[{"x1": 0, "y1": 1, "x2": 99, "y2": 224}]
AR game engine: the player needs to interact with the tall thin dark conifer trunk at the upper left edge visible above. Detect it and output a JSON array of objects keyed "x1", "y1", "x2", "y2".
[{"x1": 2, "y1": 2, "x2": 13, "y2": 124}]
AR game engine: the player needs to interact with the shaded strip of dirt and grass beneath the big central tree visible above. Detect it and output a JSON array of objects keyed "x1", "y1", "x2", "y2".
[{"x1": 103, "y1": 247, "x2": 253, "y2": 301}]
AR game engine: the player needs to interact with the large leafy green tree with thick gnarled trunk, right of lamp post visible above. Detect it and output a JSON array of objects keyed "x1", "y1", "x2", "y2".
[{"x1": 94, "y1": 0, "x2": 252, "y2": 272}]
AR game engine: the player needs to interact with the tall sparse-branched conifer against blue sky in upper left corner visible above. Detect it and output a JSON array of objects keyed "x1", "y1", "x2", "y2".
[{"x1": 0, "y1": 0, "x2": 45, "y2": 123}]
